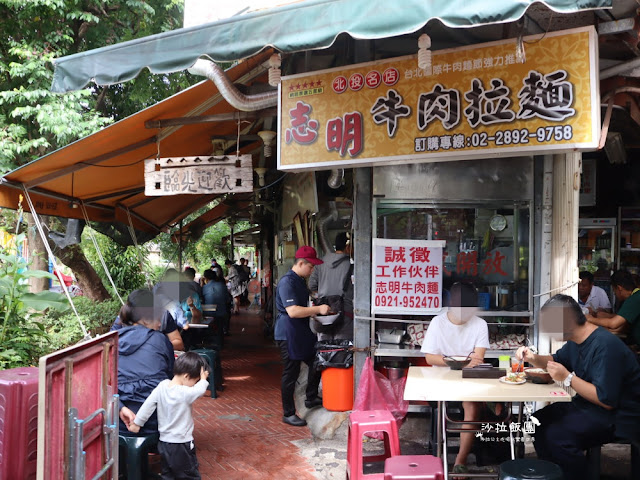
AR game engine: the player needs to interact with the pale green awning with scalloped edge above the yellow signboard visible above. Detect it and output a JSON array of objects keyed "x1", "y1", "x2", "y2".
[{"x1": 51, "y1": 0, "x2": 612, "y2": 92}]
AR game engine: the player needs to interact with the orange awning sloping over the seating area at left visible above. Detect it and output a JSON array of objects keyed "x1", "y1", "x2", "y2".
[{"x1": 0, "y1": 51, "x2": 271, "y2": 233}]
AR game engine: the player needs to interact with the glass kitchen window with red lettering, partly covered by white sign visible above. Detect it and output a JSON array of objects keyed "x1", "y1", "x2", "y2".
[{"x1": 376, "y1": 203, "x2": 531, "y2": 311}]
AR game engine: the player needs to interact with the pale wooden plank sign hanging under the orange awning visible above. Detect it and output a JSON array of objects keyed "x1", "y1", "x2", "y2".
[{"x1": 144, "y1": 155, "x2": 253, "y2": 197}]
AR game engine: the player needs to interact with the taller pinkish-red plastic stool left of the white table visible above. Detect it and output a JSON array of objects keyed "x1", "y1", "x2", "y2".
[{"x1": 347, "y1": 410, "x2": 400, "y2": 480}]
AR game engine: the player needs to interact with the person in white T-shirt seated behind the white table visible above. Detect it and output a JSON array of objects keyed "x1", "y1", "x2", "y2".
[{"x1": 421, "y1": 283, "x2": 489, "y2": 473}]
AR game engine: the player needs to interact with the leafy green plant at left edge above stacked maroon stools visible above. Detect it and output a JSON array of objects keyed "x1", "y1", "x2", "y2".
[{"x1": 0, "y1": 234, "x2": 69, "y2": 370}]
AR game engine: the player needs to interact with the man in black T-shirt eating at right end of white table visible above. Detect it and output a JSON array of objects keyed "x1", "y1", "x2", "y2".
[{"x1": 516, "y1": 295, "x2": 640, "y2": 480}]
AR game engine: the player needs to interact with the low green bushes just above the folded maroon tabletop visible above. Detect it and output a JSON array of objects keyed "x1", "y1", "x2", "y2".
[{"x1": 42, "y1": 297, "x2": 120, "y2": 355}]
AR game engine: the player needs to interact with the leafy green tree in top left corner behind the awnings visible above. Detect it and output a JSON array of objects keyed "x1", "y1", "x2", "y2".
[{"x1": 0, "y1": 0, "x2": 196, "y2": 173}]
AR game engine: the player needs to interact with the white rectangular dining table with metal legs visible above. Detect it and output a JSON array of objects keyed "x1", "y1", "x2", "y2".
[{"x1": 404, "y1": 366, "x2": 571, "y2": 479}]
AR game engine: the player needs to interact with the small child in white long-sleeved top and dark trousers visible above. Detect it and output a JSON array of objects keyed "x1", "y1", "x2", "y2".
[{"x1": 127, "y1": 352, "x2": 209, "y2": 480}]
